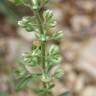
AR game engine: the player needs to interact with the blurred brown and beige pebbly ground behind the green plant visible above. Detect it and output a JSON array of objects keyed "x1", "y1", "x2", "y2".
[{"x1": 0, "y1": 0, "x2": 96, "y2": 96}]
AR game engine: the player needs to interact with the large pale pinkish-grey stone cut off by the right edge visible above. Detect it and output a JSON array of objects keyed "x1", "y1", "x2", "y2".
[{"x1": 75, "y1": 38, "x2": 96, "y2": 80}]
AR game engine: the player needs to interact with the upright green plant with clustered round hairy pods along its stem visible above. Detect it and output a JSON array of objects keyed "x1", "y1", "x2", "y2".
[{"x1": 10, "y1": 0, "x2": 67, "y2": 96}]
